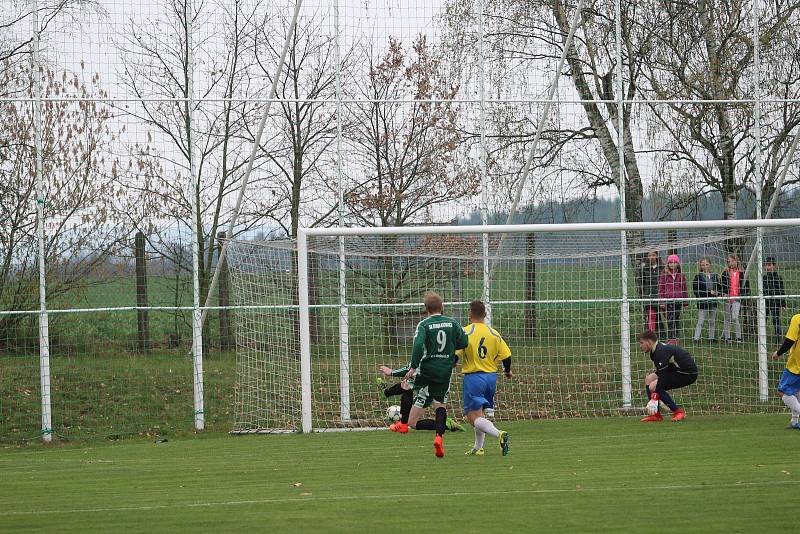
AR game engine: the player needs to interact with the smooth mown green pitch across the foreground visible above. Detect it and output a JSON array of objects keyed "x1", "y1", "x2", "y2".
[{"x1": 0, "y1": 414, "x2": 800, "y2": 533}]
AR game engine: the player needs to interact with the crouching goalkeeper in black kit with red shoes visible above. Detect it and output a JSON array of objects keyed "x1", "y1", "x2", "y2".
[{"x1": 639, "y1": 330, "x2": 697, "y2": 423}]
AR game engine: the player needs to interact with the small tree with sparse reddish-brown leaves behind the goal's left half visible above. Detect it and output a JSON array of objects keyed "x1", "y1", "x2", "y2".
[{"x1": 347, "y1": 35, "x2": 480, "y2": 340}]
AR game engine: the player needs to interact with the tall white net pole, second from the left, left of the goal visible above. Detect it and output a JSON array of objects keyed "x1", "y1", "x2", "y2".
[{"x1": 184, "y1": 0, "x2": 206, "y2": 430}]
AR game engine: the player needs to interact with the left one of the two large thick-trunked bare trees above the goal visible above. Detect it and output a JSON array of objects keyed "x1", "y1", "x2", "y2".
[{"x1": 444, "y1": 0, "x2": 650, "y2": 245}]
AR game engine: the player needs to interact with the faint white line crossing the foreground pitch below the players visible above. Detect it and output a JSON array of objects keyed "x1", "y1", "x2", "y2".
[{"x1": 0, "y1": 480, "x2": 800, "y2": 517}]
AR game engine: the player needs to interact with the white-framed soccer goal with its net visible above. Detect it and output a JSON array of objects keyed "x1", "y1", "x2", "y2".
[{"x1": 229, "y1": 219, "x2": 800, "y2": 433}]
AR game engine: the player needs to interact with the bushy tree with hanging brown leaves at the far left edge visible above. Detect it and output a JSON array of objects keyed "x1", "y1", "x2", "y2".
[{"x1": 0, "y1": 64, "x2": 128, "y2": 352}]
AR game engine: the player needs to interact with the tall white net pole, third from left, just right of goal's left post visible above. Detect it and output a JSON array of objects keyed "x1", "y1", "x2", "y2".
[{"x1": 333, "y1": 0, "x2": 350, "y2": 422}]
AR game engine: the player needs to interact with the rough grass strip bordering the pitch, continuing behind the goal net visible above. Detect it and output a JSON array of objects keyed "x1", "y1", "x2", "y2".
[{"x1": 0, "y1": 338, "x2": 784, "y2": 444}]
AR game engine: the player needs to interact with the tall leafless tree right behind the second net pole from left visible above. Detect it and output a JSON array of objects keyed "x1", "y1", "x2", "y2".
[{"x1": 119, "y1": 0, "x2": 277, "y2": 348}]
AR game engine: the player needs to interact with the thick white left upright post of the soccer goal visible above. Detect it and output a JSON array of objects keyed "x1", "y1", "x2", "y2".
[{"x1": 297, "y1": 228, "x2": 314, "y2": 434}]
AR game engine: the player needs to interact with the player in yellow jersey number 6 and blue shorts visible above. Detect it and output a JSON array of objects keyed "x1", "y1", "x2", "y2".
[{"x1": 456, "y1": 300, "x2": 512, "y2": 456}]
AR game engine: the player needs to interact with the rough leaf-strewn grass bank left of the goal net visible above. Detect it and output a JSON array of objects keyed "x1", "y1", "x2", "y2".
[{"x1": 0, "y1": 347, "x2": 236, "y2": 443}]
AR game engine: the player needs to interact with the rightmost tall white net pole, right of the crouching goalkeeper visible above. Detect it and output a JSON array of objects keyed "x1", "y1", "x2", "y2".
[{"x1": 753, "y1": 0, "x2": 769, "y2": 401}]
